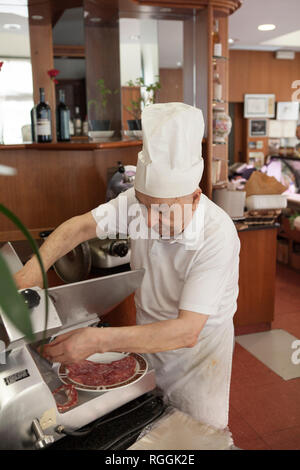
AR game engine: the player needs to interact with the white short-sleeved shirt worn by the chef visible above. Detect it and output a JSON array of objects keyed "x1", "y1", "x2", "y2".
[{"x1": 92, "y1": 188, "x2": 240, "y2": 329}]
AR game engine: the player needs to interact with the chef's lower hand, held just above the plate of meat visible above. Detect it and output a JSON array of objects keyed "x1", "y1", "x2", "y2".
[{"x1": 43, "y1": 327, "x2": 102, "y2": 363}]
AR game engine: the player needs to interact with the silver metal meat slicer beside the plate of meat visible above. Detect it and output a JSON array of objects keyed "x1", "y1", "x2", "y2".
[{"x1": 0, "y1": 243, "x2": 155, "y2": 450}]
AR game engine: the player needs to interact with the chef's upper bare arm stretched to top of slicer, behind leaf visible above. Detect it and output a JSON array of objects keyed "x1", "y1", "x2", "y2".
[{"x1": 14, "y1": 212, "x2": 97, "y2": 289}]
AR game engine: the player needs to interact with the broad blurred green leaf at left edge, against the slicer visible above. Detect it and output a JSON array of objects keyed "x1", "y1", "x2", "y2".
[{"x1": 0, "y1": 256, "x2": 34, "y2": 341}]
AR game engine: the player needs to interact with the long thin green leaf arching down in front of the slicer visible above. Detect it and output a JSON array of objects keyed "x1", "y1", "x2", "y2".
[{"x1": 0, "y1": 204, "x2": 49, "y2": 339}]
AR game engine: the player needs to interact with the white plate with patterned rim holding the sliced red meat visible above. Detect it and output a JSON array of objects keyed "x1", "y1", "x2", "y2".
[{"x1": 58, "y1": 352, "x2": 148, "y2": 393}]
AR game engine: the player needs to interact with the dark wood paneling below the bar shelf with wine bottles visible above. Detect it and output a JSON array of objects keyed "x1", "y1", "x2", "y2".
[{"x1": 0, "y1": 146, "x2": 141, "y2": 241}]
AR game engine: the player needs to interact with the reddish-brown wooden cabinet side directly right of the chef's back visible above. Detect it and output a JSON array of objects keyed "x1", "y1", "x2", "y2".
[{"x1": 234, "y1": 227, "x2": 277, "y2": 334}]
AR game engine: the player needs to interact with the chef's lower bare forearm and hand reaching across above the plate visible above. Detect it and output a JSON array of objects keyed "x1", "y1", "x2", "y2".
[{"x1": 44, "y1": 310, "x2": 208, "y2": 363}]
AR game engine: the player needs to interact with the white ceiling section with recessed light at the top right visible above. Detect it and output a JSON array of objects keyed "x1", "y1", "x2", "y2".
[{"x1": 229, "y1": 0, "x2": 300, "y2": 51}]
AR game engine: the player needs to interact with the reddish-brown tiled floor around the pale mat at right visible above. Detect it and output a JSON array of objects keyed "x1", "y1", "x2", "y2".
[{"x1": 229, "y1": 264, "x2": 300, "y2": 450}]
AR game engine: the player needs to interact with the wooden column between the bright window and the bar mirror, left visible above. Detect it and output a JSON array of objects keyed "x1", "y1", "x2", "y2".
[{"x1": 28, "y1": 2, "x2": 56, "y2": 142}]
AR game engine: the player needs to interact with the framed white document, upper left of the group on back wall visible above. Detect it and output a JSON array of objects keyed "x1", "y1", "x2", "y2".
[{"x1": 244, "y1": 94, "x2": 275, "y2": 118}]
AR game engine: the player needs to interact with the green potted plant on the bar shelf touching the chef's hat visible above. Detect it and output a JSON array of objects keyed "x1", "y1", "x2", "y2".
[{"x1": 125, "y1": 77, "x2": 161, "y2": 130}]
